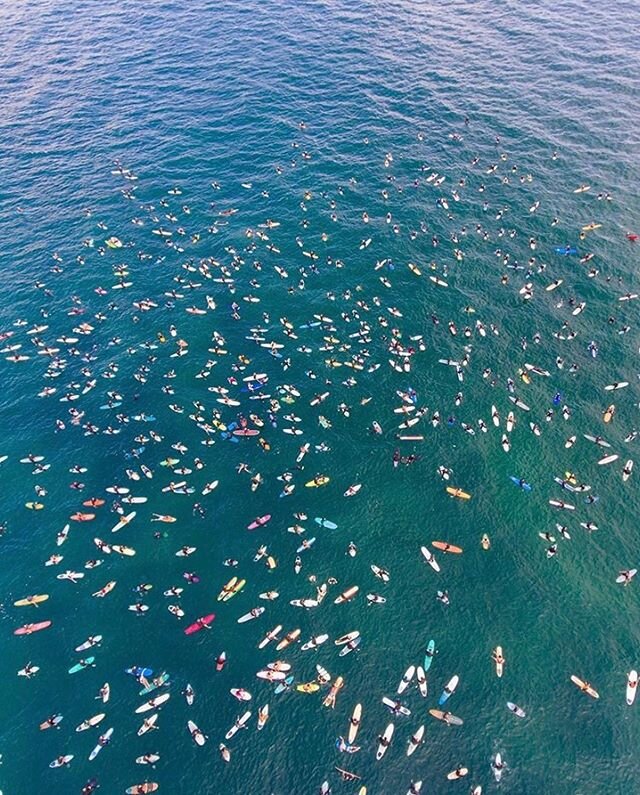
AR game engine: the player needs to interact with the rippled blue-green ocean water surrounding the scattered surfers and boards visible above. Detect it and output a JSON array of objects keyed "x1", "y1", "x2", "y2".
[{"x1": 0, "y1": 0, "x2": 640, "y2": 795}]
